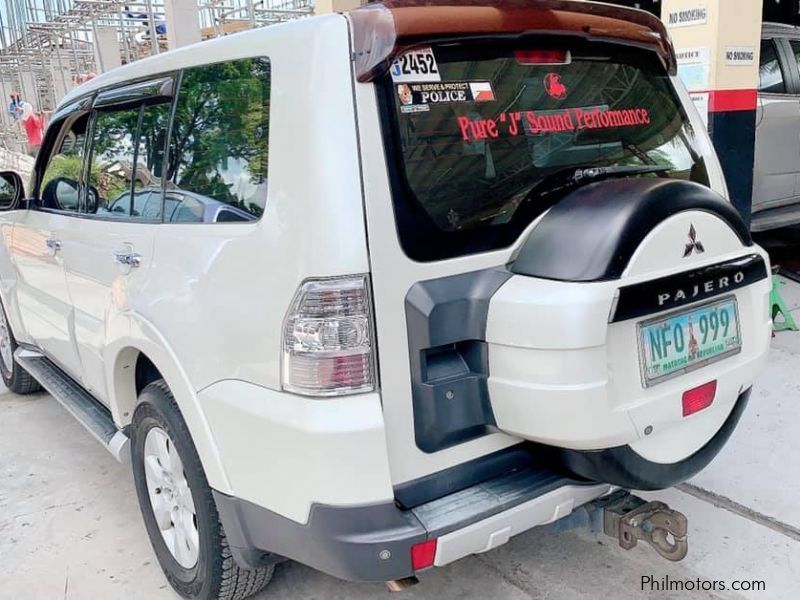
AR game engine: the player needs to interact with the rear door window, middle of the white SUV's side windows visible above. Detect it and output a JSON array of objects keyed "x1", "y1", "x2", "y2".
[{"x1": 88, "y1": 104, "x2": 169, "y2": 221}]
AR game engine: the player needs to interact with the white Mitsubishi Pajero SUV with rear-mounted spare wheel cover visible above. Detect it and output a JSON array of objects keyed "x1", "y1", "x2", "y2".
[{"x1": 0, "y1": 0, "x2": 771, "y2": 598}]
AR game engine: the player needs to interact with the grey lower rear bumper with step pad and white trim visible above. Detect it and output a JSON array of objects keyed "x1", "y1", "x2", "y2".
[{"x1": 214, "y1": 468, "x2": 612, "y2": 581}]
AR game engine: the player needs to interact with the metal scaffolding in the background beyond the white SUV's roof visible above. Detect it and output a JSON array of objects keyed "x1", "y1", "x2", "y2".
[{"x1": 0, "y1": 0, "x2": 314, "y2": 152}]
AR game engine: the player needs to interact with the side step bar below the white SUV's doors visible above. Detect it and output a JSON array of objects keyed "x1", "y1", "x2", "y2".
[{"x1": 14, "y1": 348, "x2": 130, "y2": 463}]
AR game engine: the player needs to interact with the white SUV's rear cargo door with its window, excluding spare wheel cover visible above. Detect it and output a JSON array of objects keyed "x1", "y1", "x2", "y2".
[{"x1": 355, "y1": 37, "x2": 720, "y2": 483}]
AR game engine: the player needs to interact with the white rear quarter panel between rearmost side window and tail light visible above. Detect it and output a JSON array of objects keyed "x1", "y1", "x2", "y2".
[{"x1": 137, "y1": 15, "x2": 369, "y2": 390}]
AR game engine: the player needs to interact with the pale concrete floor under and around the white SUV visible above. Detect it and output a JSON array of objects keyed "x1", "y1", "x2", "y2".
[{"x1": 0, "y1": 285, "x2": 800, "y2": 600}]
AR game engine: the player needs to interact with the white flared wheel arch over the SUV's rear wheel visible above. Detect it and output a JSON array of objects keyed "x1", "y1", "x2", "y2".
[{"x1": 104, "y1": 317, "x2": 232, "y2": 493}]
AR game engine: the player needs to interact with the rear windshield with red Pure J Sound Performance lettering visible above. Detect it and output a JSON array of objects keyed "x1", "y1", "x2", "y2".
[{"x1": 378, "y1": 42, "x2": 708, "y2": 261}]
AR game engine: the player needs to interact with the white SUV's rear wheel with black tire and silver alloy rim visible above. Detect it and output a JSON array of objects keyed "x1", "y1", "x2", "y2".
[{"x1": 131, "y1": 379, "x2": 275, "y2": 600}]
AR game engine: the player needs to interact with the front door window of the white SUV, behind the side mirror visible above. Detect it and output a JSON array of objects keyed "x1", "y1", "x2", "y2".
[{"x1": 39, "y1": 115, "x2": 89, "y2": 212}]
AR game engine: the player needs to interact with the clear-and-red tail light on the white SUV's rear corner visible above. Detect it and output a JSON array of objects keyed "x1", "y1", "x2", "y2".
[{"x1": 283, "y1": 275, "x2": 375, "y2": 396}]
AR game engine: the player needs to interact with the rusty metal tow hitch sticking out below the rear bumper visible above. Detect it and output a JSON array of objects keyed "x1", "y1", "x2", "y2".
[{"x1": 596, "y1": 490, "x2": 689, "y2": 561}]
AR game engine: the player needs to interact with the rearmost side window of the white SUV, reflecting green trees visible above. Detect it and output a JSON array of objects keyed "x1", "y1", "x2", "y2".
[{"x1": 165, "y1": 58, "x2": 270, "y2": 222}]
